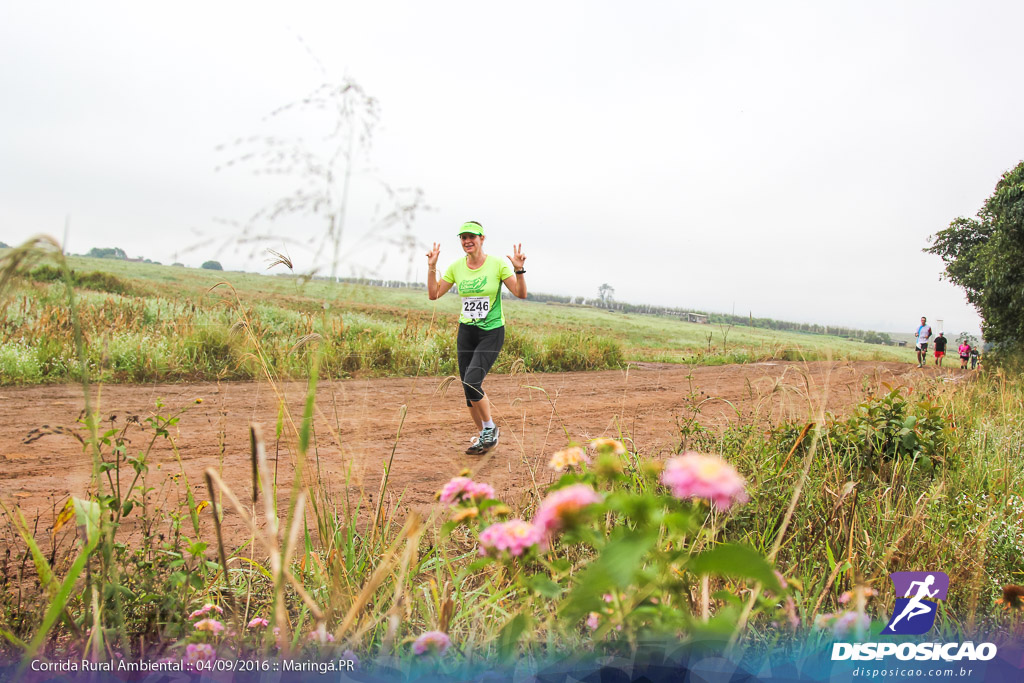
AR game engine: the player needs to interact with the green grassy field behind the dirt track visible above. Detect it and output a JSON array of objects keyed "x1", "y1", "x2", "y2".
[{"x1": 0, "y1": 257, "x2": 912, "y2": 384}]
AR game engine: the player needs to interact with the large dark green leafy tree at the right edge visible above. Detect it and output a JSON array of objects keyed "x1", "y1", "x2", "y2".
[{"x1": 925, "y1": 162, "x2": 1024, "y2": 346}]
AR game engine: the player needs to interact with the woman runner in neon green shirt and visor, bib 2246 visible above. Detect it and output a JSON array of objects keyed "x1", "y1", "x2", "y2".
[{"x1": 427, "y1": 220, "x2": 526, "y2": 455}]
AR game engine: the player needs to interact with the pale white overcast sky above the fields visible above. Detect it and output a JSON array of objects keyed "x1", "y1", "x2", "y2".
[{"x1": 0, "y1": 0, "x2": 1024, "y2": 333}]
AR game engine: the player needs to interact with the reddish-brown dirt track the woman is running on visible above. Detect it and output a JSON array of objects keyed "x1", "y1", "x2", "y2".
[{"x1": 0, "y1": 361, "x2": 931, "y2": 548}]
